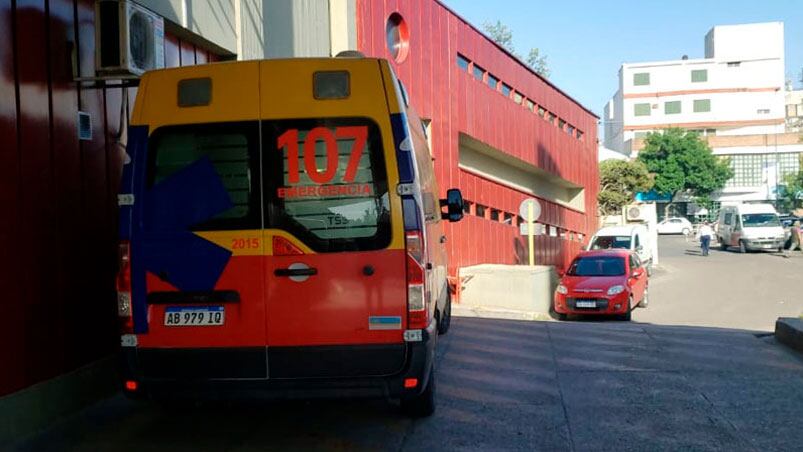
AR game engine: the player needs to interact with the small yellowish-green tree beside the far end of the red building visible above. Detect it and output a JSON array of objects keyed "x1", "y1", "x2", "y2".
[{"x1": 597, "y1": 160, "x2": 653, "y2": 215}]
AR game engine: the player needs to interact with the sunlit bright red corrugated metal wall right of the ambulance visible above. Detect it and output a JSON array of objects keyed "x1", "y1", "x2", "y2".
[{"x1": 357, "y1": 0, "x2": 598, "y2": 267}]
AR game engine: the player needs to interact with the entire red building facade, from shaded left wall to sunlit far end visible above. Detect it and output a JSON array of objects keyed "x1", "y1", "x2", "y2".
[{"x1": 0, "y1": 0, "x2": 598, "y2": 408}]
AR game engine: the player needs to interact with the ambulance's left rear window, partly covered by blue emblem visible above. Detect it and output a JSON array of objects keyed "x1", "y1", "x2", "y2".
[{"x1": 149, "y1": 121, "x2": 262, "y2": 231}]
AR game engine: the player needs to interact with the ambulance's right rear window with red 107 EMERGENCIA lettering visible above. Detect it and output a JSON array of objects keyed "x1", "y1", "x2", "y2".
[{"x1": 262, "y1": 118, "x2": 390, "y2": 252}]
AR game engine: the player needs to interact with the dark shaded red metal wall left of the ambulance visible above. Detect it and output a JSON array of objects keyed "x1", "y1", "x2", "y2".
[{"x1": 0, "y1": 0, "x2": 220, "y2": 395}]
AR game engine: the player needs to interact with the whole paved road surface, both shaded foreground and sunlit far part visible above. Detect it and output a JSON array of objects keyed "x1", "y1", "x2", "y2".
[{"x1": 11, "y1": 238, "x2": 803, "y2": 452}]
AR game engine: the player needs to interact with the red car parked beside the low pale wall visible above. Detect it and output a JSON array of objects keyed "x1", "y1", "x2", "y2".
[{"x1": 554, "y1": 250, "x2": 649, "y2": 320}]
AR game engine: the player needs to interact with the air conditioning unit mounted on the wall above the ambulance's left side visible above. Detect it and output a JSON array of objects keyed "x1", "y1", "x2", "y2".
[{"x1": 95, "y1": 0, "x2": 164, "y2": 76}]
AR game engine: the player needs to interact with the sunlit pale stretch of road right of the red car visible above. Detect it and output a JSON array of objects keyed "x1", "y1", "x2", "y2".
[{"x1": 633, "y1": 236, "x2": 803, "y2": 331}]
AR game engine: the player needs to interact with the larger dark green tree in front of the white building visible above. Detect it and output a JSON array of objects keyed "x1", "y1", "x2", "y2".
[{"x1": 638, "y1": 129, "x2": 733, "y2": 205}]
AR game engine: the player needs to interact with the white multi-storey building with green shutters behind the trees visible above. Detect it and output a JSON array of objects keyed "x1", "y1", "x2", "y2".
[{"x1": 604, "y1": 22, "x2": 803, "y2": 209}]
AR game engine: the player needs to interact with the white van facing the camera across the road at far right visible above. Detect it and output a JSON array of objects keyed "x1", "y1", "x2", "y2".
[{"x1": 717, "y1": 204, "x2": 784, "y2": 253}]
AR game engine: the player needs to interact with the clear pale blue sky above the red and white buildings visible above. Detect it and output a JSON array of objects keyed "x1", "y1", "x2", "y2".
[{"x1": 442, "y1": 0, "x2": 803, "y2": 120}]
